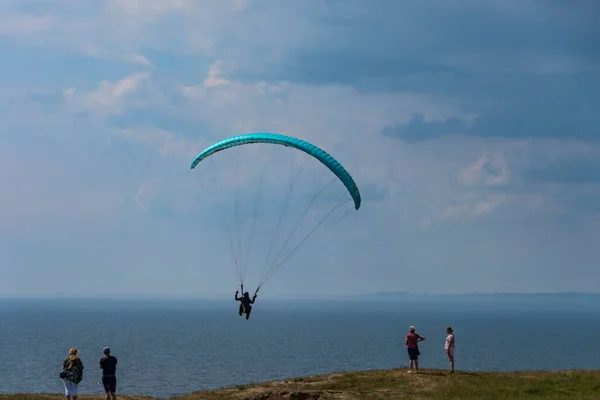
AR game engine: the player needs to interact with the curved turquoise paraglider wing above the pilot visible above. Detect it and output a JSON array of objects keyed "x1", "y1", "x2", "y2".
[{"x1": 191, "y1": 132, "x2": 361, "y2": 210}]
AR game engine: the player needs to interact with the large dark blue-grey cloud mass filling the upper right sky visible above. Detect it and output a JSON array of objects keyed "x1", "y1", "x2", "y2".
[{"x1": 220, "y1": 0, "x2": 600, "y2": 142}]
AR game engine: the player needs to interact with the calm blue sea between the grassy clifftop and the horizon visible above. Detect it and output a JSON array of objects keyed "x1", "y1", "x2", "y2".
[{"x1": 0, "y1": 299, "x2": 600, "y2": 398}]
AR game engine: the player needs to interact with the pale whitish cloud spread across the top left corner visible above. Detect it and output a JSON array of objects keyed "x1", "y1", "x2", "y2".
[{"x1": 0, "y1": 0, "x2": 246, "y2": 66}]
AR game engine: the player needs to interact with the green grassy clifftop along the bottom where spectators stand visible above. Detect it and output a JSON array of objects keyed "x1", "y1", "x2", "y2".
[{"x1": 0, "y1": 368, "x2": 600, "y2": 400}]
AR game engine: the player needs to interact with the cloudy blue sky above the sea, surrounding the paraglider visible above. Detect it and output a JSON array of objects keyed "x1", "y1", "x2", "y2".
[{"x1": 0, "y1": 0, "x2": 600, "y2": 297}]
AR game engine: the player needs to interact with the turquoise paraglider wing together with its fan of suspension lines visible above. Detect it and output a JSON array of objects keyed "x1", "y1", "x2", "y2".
[{"x1": 191, "y1": 132, "x2": 361, "y2": 293}]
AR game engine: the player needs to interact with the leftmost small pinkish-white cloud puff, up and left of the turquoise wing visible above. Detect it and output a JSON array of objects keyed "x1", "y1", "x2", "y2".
[{"x1": 63, "y1": 72, "x2": 150, "y2": 114}]
